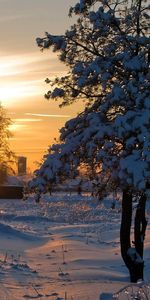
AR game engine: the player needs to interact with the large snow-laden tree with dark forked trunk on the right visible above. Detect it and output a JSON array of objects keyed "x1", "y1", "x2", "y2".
[{"x1": 30, "y1": 0, "x2": 150, "y2": 282}]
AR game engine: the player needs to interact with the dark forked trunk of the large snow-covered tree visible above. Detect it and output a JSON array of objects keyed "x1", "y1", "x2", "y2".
[{"x1": 120, "y1": 190, "x2": 147, "y2": 282}]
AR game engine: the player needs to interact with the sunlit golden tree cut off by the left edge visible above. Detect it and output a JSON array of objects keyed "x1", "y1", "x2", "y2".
[{"x1": 0, "y1": 105, "x2": 14, "y2": 183}]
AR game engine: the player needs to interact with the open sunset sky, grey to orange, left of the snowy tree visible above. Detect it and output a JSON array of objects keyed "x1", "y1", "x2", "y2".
[{"x1": 0, "y1": 0, "x2": 80, "y2": 170}]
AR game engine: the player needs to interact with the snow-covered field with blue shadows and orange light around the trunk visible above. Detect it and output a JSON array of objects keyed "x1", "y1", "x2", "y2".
[{"x1": 0, "y1": 193, "x2": 150, "y2": 300}]
